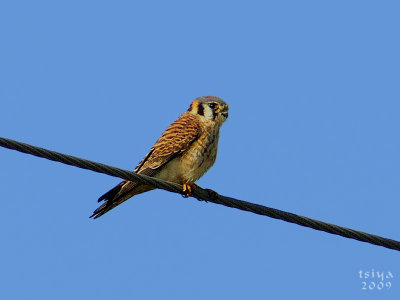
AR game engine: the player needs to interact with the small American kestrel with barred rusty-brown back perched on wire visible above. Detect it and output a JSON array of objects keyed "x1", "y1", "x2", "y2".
[{"x1": 90, "y1": 96, "x2": 228, "y2": 219}]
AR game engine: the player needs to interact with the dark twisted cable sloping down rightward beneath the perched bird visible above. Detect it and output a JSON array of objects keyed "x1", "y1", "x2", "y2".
[{"x1": 0, "y1": 137, "x2": 400, "y2": 251}]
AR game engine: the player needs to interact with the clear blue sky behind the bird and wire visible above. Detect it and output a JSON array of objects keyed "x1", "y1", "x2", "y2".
[{"x1": 0, "y1": 1, "x2": 400, "y2": 300}]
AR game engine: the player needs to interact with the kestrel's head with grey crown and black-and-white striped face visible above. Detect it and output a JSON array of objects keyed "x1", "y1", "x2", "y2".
[{"x1": 188, "y1": 96, "x2": 229, "y2": 124}]
